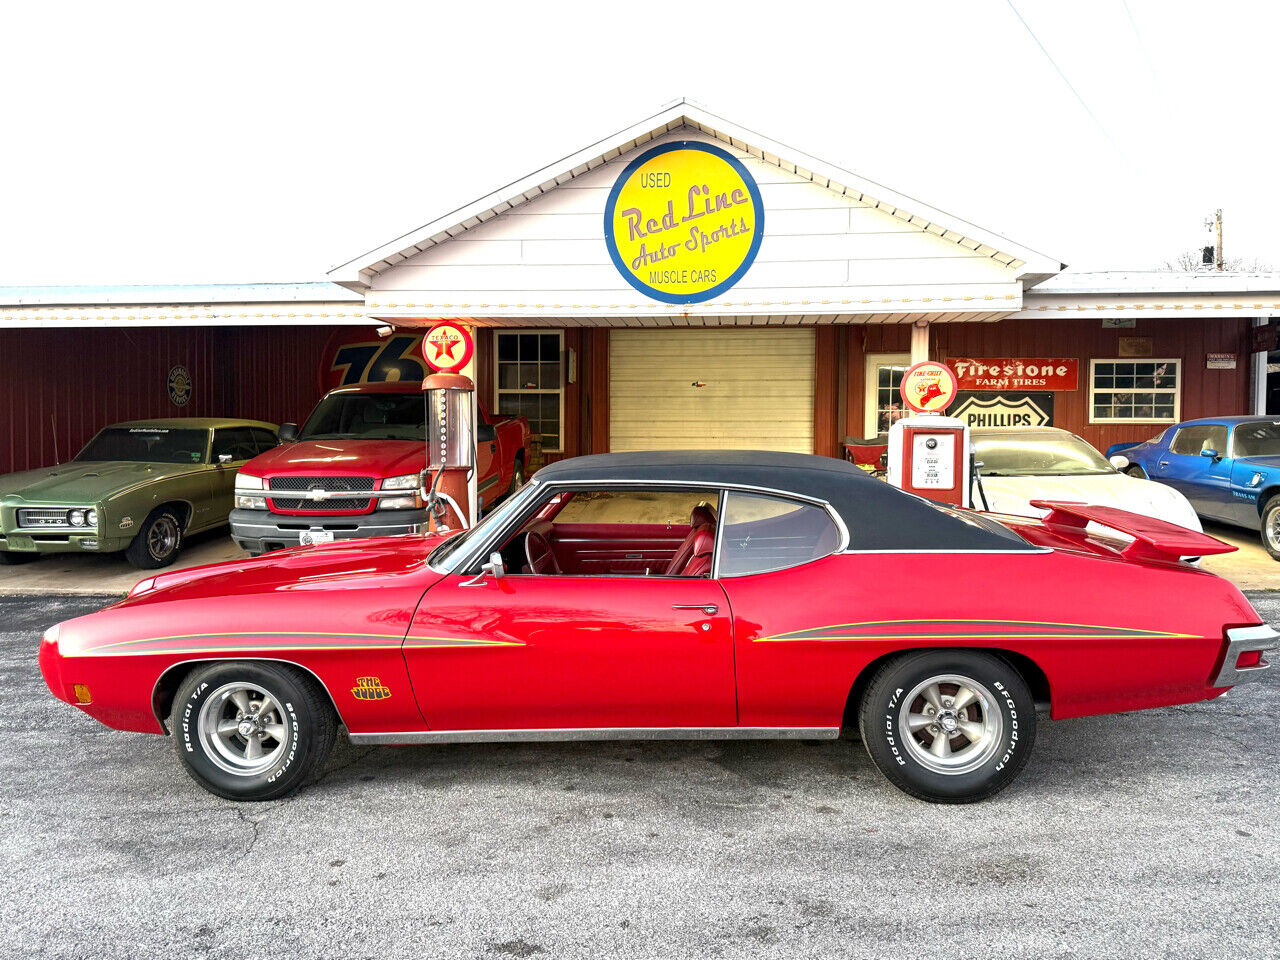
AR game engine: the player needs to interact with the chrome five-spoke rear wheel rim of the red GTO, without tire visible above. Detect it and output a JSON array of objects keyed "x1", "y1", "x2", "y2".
[{"x1": 899, "y1": 673, "x2": 1005, "y2": 776}]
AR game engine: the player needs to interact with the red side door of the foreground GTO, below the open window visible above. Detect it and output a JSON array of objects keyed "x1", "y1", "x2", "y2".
[{"x1": 404, "y1": 490, "x2": 737, "y2": 731}]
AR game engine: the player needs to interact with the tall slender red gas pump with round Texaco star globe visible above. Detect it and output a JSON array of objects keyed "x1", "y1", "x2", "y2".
[{"x1": 422, "y1": 320, "x2": 476, "y2": 532}]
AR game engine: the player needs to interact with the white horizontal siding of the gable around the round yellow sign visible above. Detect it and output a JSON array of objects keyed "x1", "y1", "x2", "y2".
[{"x1": 369, "y1": 129, "x2": 1020, "y2": 315}]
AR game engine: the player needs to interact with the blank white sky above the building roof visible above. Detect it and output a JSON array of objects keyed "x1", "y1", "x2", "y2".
[{"x1": 0, "y1": 0, "x2": 1280, "y2": 284}]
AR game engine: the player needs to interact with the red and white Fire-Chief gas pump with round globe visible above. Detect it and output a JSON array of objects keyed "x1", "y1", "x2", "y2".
[{"x1": 888, "y1": 361, "x2": 973, "y2": 507}]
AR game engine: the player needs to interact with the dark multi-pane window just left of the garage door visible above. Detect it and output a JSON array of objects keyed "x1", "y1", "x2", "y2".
[{"x1": 494, "y1": 330, "x2": 564, "y2": 453}]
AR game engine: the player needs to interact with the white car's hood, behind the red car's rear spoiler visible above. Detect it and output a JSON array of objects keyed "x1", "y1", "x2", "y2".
[{"x1": 975, "y1": 474, "x2": 1202, "y2": 530}]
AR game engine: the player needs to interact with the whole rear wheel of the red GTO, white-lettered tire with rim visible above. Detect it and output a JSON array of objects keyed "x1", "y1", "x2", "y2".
[{"x1": 858, "y1": 650, "x2": 1036, "y2": 804}]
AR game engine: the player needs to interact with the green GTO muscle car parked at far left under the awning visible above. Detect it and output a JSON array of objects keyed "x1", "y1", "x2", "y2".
[{"x1": 0, "y1": 417, "x2": 276, "y2": 570}]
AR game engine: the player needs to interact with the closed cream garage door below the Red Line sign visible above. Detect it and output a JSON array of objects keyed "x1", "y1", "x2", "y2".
[{"x1": 609, "y1": 326, "x2": 814, "y2": 453}]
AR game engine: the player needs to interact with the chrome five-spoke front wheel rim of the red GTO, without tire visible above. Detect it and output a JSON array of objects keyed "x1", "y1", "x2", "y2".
[{"x1": 197, "y1": 682, "x2": 292, "y2": 777}]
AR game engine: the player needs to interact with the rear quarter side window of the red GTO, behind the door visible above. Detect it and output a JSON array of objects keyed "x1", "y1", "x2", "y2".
[{"x1": 719, "y1": 490, "x2": 840, "y2": 577}]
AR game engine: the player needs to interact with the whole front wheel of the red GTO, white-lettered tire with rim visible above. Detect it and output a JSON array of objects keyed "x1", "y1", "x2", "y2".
[{"x1": 169, "y1": 660, "x2": 338, "y2": 800}]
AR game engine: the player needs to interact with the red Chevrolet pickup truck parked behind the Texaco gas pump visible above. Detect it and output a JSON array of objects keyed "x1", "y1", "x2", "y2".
[{"x1": 230, "y1": 381, "x2": 529, "y2": 556}]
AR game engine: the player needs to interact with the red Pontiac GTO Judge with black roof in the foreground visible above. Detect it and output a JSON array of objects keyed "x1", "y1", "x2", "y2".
[{"x1": 40, "y1": 452, "x2": 1280, "y2": 803}]
